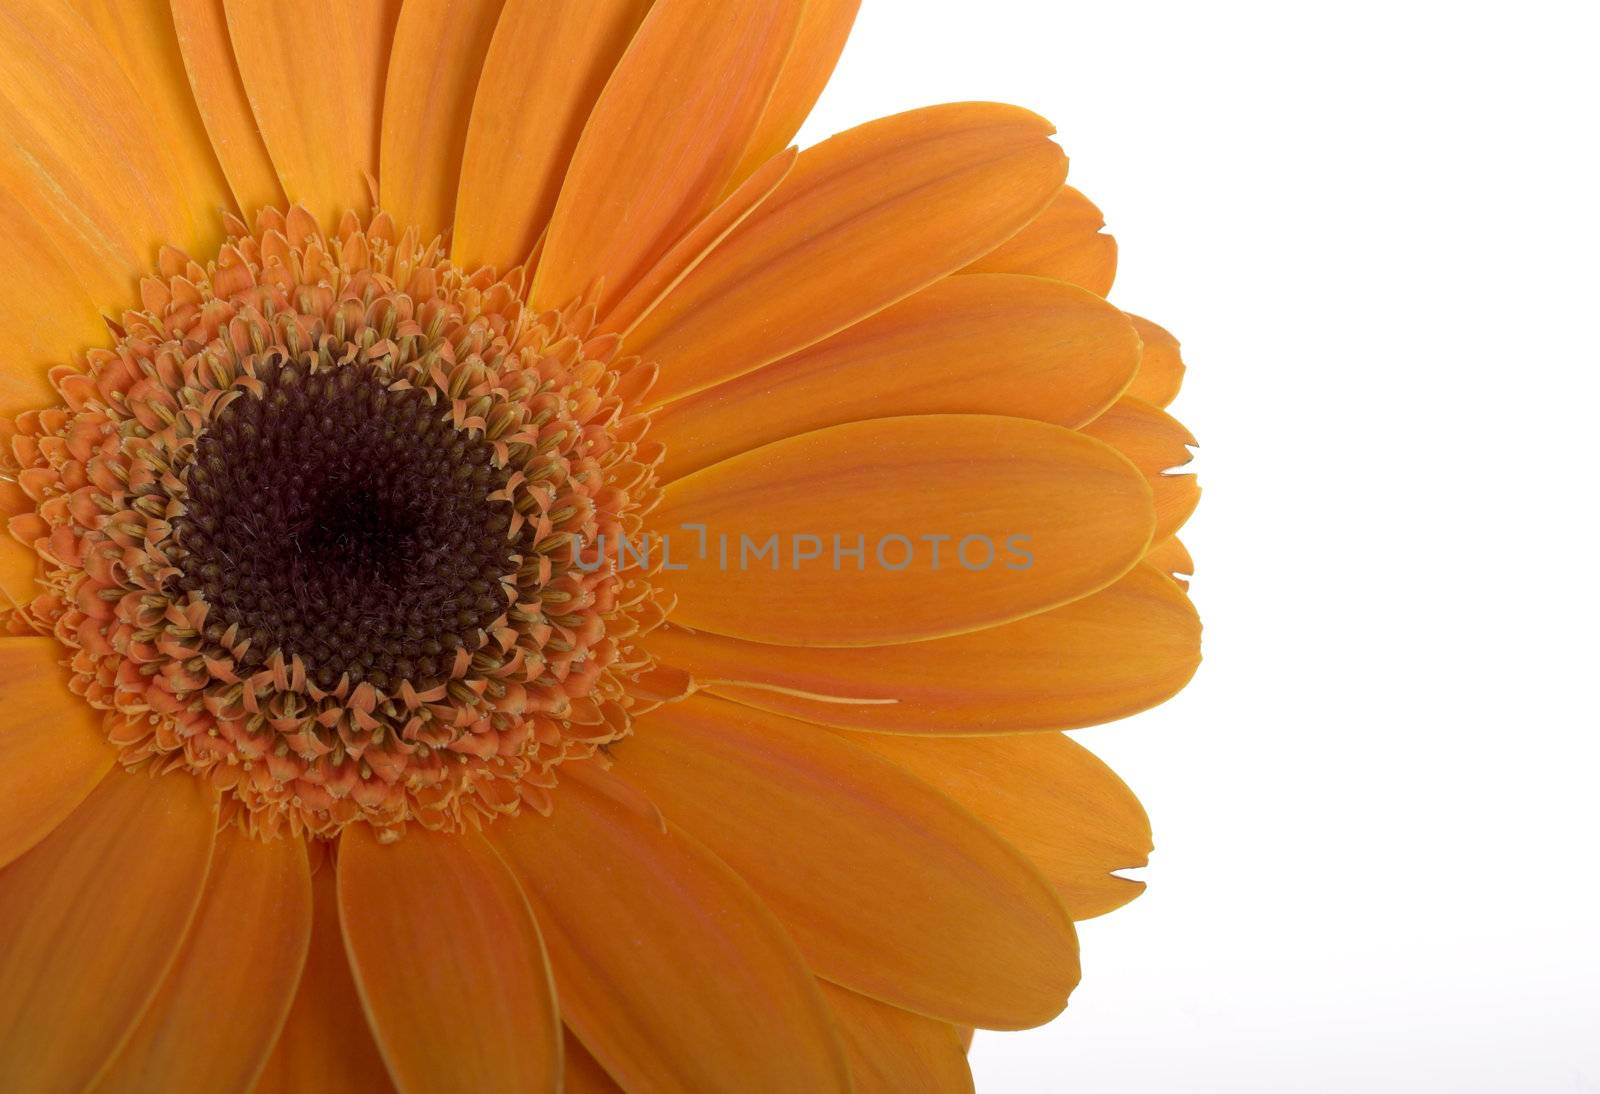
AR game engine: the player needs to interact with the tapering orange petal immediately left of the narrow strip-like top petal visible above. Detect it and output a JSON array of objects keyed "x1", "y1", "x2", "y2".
[{"x1": 74, "y1": 0, "x2": 234, "y2": 241}]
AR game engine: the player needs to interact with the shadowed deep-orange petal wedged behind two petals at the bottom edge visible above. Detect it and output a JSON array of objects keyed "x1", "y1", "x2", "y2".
[{"x1": 254, "y1": 862, "x2": 394, "y2": 1094}]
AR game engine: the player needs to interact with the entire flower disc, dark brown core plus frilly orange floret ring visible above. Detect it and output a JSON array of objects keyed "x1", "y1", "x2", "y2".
[{"x1": 0, "y1": 208, "x2": 666, "y2": 836}]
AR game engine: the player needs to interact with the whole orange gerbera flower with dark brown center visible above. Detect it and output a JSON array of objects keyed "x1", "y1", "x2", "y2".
[{"x1": 0, "y1": 0, "x2": 1198, "y2": 1092}]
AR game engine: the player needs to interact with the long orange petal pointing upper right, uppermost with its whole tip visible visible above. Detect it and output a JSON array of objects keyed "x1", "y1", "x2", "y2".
[{"x1": 629, "y1": 102, "x2": 1066, "y2": 401}]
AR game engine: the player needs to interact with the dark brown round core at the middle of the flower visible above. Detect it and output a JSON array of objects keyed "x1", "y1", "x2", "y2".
[{"x1": 174, "y1": 361, "x2": 520, "y2": 689}]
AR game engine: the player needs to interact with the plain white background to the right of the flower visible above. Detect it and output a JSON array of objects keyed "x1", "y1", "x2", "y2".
[{"x1": 803, "y1": 0, "x2": 1600, "y2": 1094}]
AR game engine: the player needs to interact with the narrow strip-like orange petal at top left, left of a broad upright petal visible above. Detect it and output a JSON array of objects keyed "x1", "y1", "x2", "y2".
[{"x1": 171, "y1": 0, "x2": 283, "y2": 218}]
